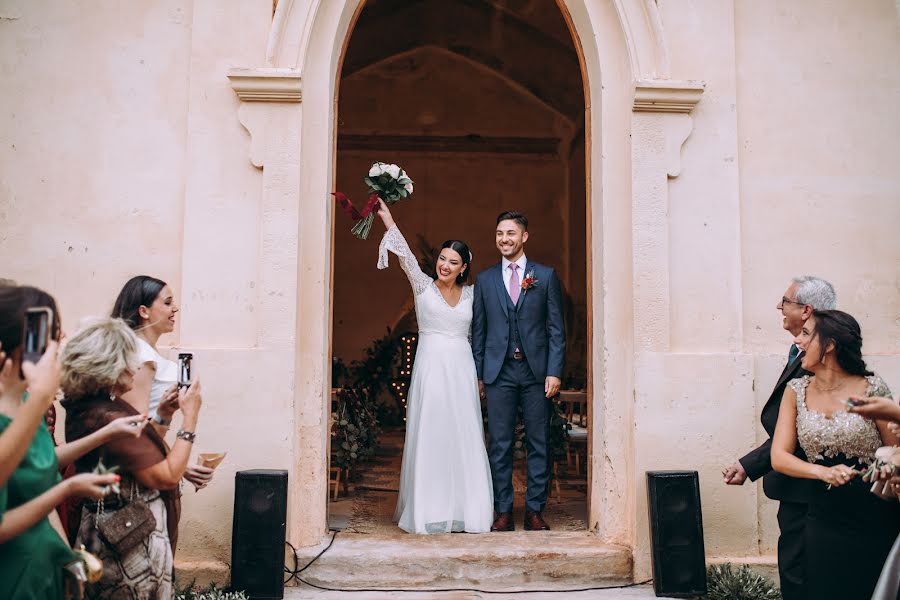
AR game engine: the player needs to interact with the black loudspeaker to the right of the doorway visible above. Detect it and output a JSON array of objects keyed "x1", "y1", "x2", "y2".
[{"x1": 647, "y1": 471, "x2": 706, "y2": 598}]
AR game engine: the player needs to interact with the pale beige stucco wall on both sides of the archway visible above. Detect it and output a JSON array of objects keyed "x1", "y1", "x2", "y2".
[{"x1": 0, "y1": 0, "x2": 900, "y2": 584}]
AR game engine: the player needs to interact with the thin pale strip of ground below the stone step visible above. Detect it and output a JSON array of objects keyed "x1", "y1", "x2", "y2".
[{"x1": 284, "y1": 585, "x2": 680, "y2": 600}]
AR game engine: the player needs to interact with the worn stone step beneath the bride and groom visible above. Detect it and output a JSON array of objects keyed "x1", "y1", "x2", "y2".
[{"x1": 297, "y1": 531, "x2": 632, "y2": 591}]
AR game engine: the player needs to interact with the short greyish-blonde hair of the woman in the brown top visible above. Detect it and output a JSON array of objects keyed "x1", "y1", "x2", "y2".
[{"x1": 60, "y1": 318, "x2": 138, "y2": 398}]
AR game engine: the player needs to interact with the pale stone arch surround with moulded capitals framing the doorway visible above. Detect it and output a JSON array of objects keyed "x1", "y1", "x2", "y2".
[{"x1": 228, "y1": 0, "x2": 703, "y2": 576}]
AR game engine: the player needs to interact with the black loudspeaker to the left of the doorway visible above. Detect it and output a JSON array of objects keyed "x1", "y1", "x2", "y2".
[{"x1": 231, "y1": 469, "x2": 287, "y2": 600}]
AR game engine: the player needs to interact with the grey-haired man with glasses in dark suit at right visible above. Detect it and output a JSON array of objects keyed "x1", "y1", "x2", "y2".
[{"x1": 722, "y1": 276, "x2": 837, "y2": 600}]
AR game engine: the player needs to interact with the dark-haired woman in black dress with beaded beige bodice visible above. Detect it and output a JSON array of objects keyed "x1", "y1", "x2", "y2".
[{"x1": 772, "y1": 310, "x2": 900, "y2": 600}]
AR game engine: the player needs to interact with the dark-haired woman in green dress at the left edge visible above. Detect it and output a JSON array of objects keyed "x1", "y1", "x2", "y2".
[{"x1": 0, "y1": 286, "x2": 124, "y2": 599}]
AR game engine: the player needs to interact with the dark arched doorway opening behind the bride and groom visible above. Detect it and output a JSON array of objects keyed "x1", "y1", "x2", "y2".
[{"x1": 330, "y1": 0, "x2": 590, "y2": 533}]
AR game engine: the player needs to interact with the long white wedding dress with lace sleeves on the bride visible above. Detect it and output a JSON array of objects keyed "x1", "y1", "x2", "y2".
[{"x1": 378, "y1": 225, "x2": 494, "y2": 533}]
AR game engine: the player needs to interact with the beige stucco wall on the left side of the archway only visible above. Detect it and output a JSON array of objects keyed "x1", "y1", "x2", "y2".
[{"x1": 0, "y1": 0, "x2": 278, "y2": 580}]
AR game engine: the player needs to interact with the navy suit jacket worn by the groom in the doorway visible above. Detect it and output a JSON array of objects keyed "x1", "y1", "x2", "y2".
[{"x1": 472, "y1": 261, "x2": 566, "y2": 384}]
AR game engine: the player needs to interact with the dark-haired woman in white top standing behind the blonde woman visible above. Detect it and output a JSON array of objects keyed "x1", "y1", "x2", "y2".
[{"x1": 111, "y1": 275, "x2": 214, "y2": 490}]
